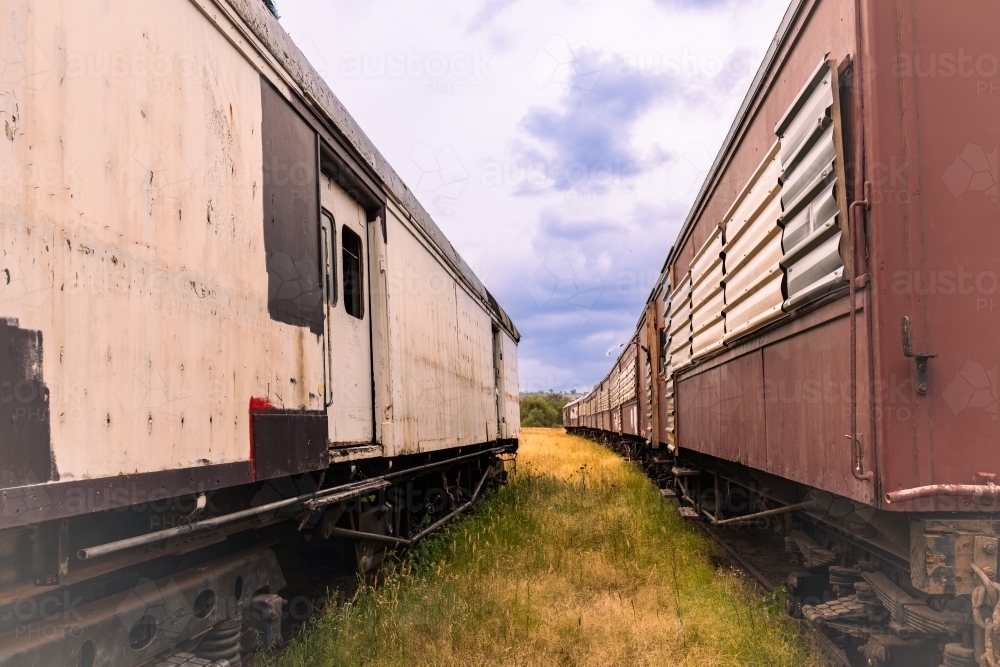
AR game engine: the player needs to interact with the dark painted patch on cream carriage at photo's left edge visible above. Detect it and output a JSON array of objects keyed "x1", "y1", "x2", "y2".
[{"x1": 0, "y1": 319, "x2": 58, "y2": 488}]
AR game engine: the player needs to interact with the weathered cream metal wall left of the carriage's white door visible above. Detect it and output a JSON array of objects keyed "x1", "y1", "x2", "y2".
[{"x1": 0, "y1": 0, "x2": 332, "y2": 486}]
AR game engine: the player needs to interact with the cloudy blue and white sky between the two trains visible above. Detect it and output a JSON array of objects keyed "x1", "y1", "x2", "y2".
[{"x1": 277, "y1": 0, "x2": 788, "y2": 391}]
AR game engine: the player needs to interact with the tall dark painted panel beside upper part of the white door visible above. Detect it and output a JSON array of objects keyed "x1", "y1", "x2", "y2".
[{"x1": 261, "y1": 78, "x2": 324, "y2": 334}]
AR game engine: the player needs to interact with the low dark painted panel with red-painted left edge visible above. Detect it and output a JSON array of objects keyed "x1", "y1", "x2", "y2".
[{"x1": 253, "y1": 411, "x2": 330, "y2": 479}]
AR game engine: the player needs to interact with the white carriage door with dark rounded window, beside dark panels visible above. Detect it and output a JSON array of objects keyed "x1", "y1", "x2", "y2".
[{"x1": 320, "y1": 174, "x2": 374, "y2": 447}]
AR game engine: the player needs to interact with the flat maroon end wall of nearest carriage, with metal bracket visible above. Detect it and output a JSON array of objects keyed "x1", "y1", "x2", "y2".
[{"x1": 865, "y1": 0, "x2": 1000, "y2": 511}]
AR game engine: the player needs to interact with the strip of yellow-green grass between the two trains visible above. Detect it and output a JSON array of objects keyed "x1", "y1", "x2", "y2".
[{"x1": 268, "y1": 429, "x2": 820, "y2": 667}]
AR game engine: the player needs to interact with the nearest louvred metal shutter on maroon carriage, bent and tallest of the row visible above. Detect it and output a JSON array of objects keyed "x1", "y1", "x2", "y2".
[{"x1": 774, "y1": 60, "x2": 846, "y2": 311}]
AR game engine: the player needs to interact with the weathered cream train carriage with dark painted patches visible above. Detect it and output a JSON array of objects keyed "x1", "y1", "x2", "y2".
[{"x1": 0, "y1": 0, "x2": 520, "y2": 666}]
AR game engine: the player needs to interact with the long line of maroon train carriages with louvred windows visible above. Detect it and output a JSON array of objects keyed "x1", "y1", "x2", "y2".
[{"x1": 563, "y1": 0, "x2": 1000, "y2": 667}]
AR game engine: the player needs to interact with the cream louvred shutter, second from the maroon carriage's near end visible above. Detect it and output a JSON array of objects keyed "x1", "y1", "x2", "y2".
[{"x1": 723, "y1": 143, "x2": 784, "y2": 344}]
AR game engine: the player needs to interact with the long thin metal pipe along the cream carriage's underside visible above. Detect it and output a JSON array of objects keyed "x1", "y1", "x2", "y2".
[{"x1": 77, "y1": 447, "x2": 509, "y2": 560}]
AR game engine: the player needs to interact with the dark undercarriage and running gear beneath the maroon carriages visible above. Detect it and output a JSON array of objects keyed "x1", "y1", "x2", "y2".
[{"x1": 595, "y1": 437, "x2": 974, "y2": 667}]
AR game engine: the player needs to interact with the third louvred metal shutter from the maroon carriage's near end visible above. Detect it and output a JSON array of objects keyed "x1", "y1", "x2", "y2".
[{"x1": 691, "y1": 227, "x2": 726, "y2": 359}]
